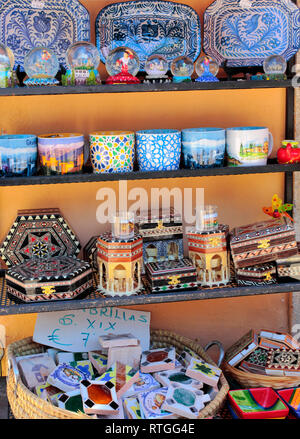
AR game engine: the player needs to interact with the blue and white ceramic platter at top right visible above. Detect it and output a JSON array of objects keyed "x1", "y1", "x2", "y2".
[{"x1": 203, "y1": 0, "x2": 300, "y2": 67}]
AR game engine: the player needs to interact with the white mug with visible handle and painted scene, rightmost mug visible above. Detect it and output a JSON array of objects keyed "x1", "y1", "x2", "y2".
[{"x1": 226, "y1": 126, "x2": 273, "y2": 166}]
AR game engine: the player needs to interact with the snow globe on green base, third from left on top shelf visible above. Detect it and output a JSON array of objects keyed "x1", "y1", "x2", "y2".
[{"x1": 62, "y1": 41, "x2": 101, "y2": 85}]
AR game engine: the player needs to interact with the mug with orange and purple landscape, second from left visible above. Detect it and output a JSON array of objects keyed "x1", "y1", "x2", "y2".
[{"x1": 38, "y1": 133, "x2": 84, "y2": 175}]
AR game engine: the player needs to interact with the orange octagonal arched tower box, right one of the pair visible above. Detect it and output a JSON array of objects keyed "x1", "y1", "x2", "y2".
[{"x1": 187, "y1": 223, "x2": 230, "y2": 287}]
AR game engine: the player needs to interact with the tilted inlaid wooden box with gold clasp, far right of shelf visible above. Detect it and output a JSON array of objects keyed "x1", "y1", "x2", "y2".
[{"x1": 230, "y1": 218, "x2": 298, "y2": 269}]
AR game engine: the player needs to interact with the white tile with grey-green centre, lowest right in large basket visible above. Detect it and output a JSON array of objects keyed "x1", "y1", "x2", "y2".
[{"x1": 162, "y1": 383, "x2": 210, "y2": 419}]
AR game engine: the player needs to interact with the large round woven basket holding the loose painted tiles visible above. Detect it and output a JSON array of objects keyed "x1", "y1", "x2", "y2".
[{"x1": 7, "y1": 330, "x2": 229, "y2": 419}]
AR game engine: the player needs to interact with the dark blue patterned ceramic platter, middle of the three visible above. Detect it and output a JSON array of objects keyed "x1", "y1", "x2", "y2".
[{"x1": 96, "y1": 0, "x2": 201, "y2": 70}]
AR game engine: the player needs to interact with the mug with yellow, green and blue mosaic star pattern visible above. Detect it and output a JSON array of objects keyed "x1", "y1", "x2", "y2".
[{"x1": 89, "y1": 131, "x2": 135, "y2": 174}]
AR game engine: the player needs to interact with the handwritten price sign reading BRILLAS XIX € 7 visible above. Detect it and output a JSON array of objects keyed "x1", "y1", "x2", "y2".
[{"x1": 33, "y1": 307, "x2": 150, "y2": 352}]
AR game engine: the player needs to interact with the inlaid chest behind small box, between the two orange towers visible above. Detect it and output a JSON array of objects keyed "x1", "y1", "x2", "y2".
[{"x1": 136, "y1": 208, "x2": 184, "y2": 264}]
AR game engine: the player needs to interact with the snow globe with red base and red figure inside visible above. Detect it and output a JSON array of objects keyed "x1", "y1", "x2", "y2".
[{"x1": 105, "y1": 46, "x2": 140, "y2": 84}]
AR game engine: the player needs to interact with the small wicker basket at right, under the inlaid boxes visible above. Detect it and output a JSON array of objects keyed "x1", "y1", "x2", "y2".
[{"x1": 222, "y1": 362, "x2": 300, "y2": 390}]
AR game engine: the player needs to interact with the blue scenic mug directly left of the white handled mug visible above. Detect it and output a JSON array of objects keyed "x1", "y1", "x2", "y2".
[{"x1": 182, "y1": 128, "x2": 226, "y2": 169}]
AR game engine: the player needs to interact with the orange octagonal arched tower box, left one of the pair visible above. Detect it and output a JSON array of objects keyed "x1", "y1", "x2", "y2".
[{"x1": 97, "y1": 232, "x2": 143, "y2": 296}]
